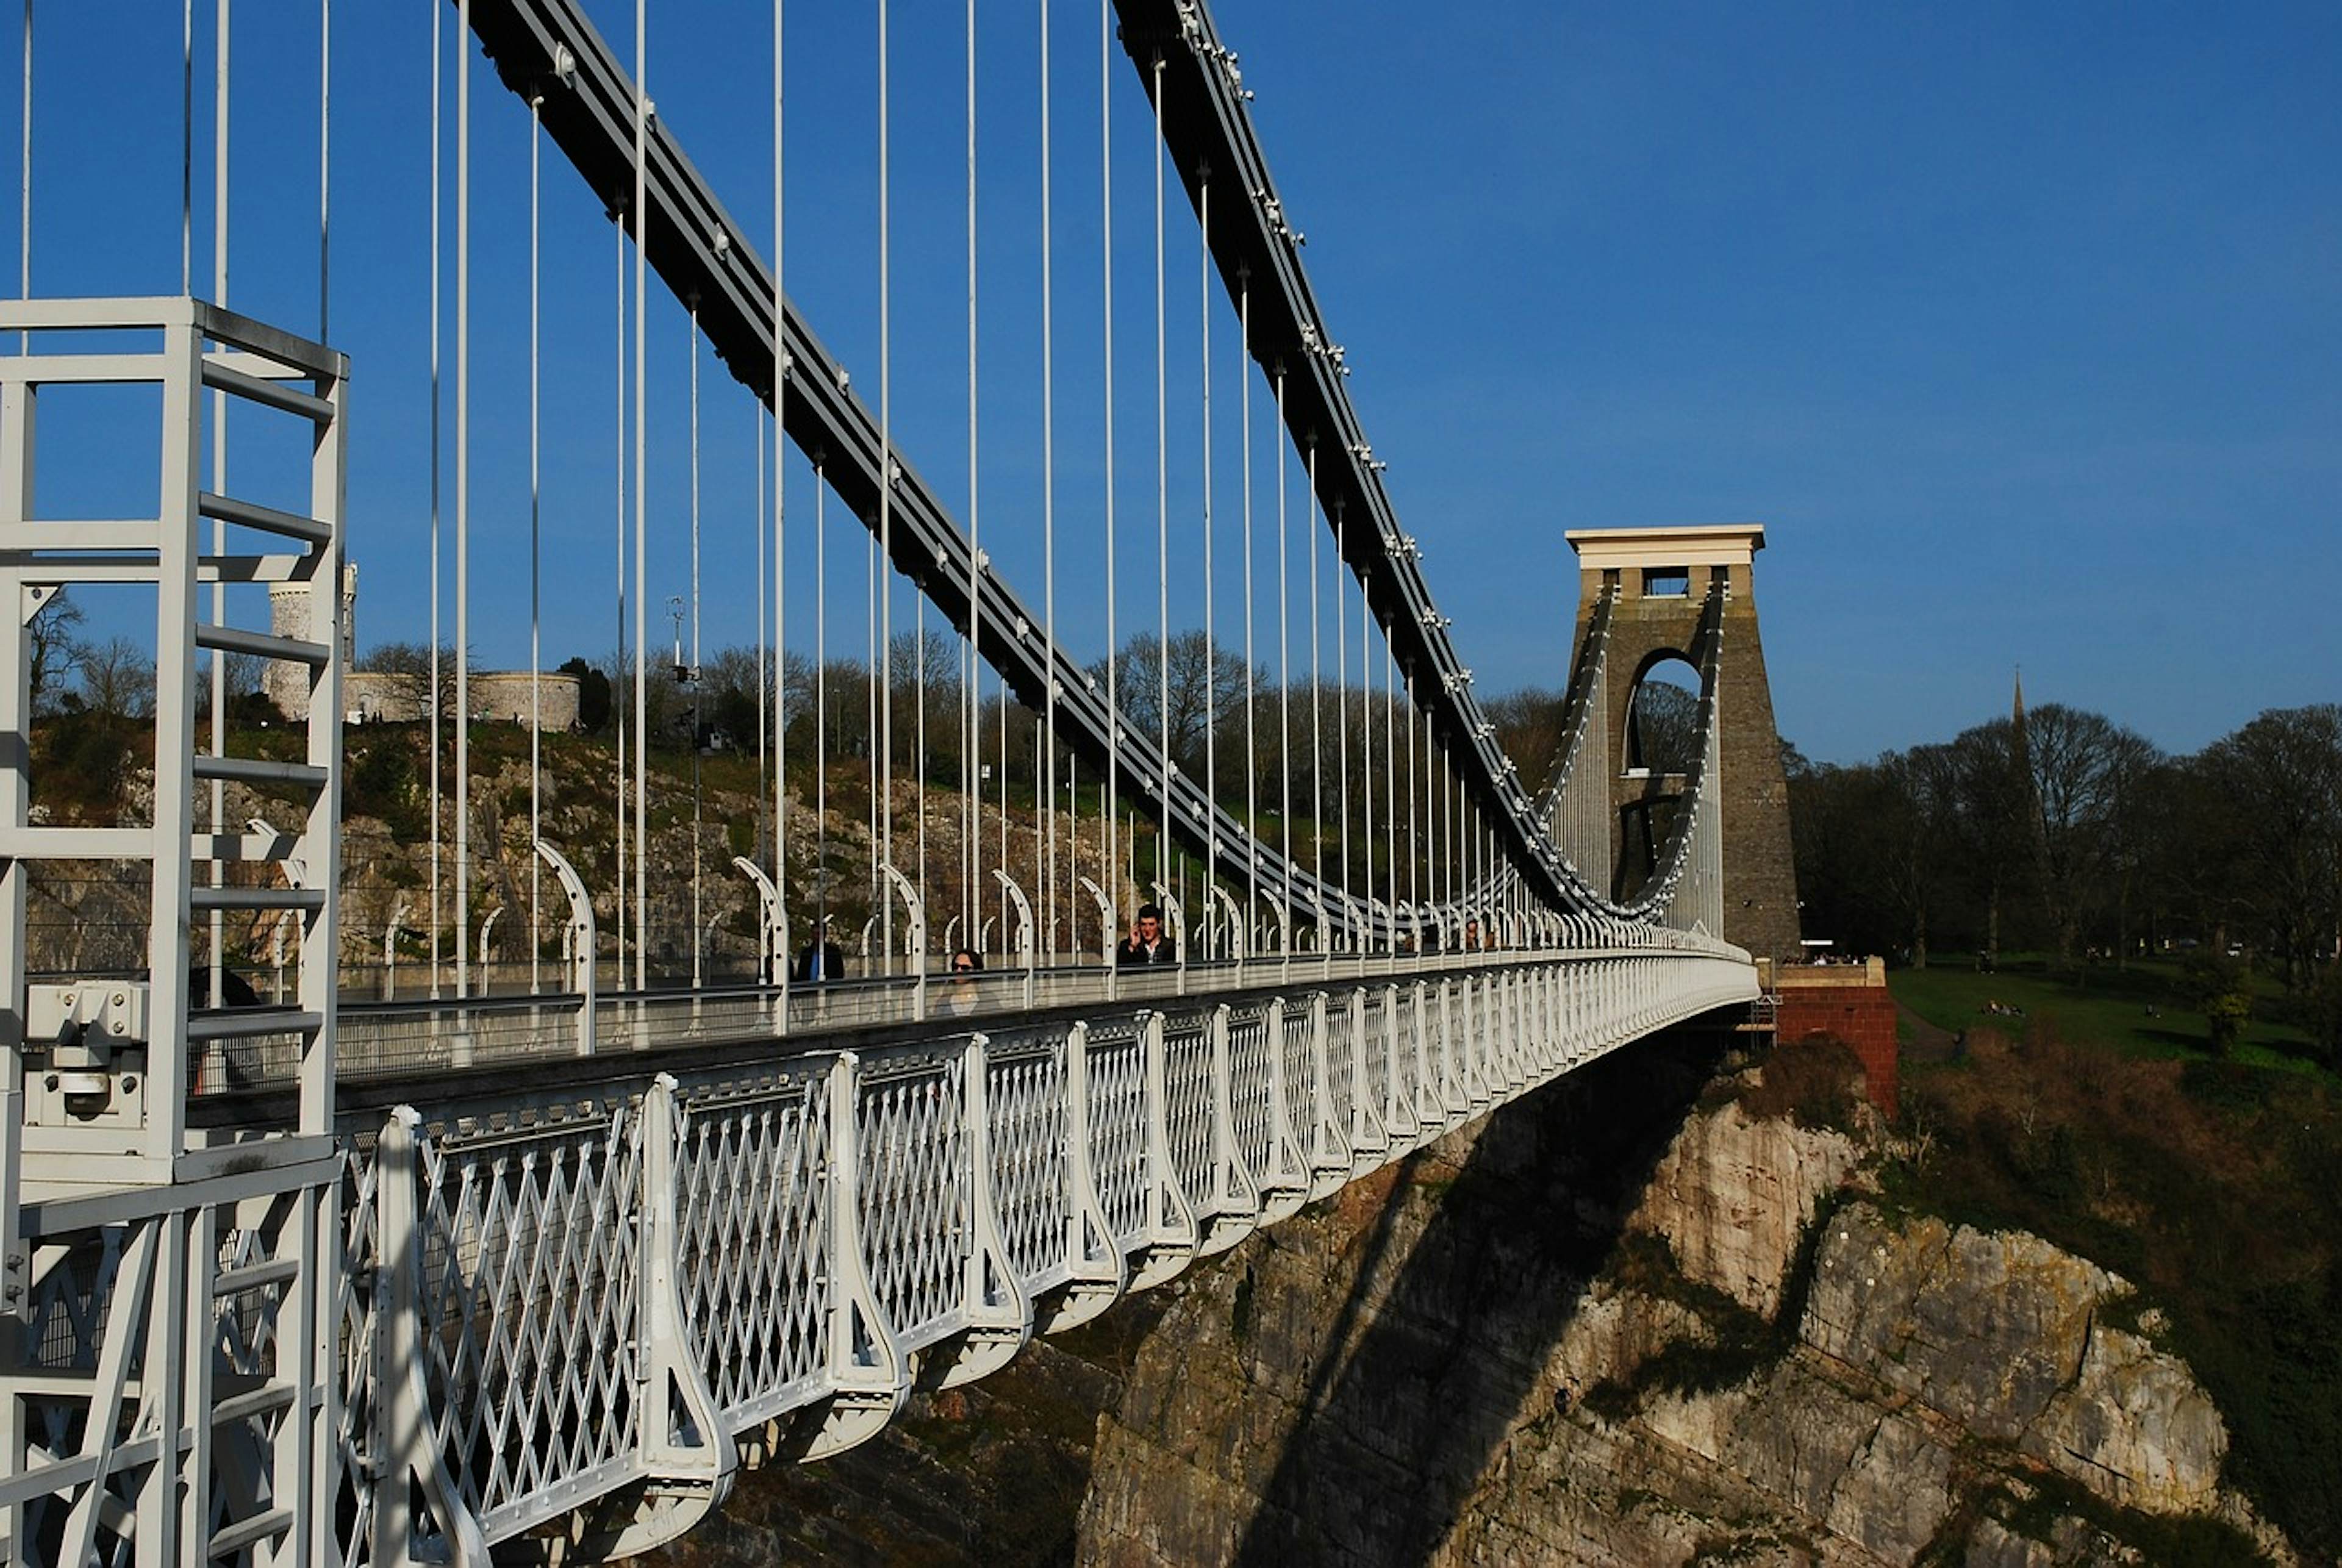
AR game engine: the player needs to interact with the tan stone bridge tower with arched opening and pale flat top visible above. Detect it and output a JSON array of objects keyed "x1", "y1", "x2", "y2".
[{"x1": 1564, "y1": 522, "x2": 1799, "y2": 964}]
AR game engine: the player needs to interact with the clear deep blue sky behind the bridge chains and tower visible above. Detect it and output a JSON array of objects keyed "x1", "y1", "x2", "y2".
[{"x1": 0, "y1": 0, "x2": 2342, "y2": 761}]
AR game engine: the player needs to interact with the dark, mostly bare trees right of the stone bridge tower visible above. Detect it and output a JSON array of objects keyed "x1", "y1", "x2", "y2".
[{"x1": 1785, "y1": 702, "x2": 2342, "y2": 995}]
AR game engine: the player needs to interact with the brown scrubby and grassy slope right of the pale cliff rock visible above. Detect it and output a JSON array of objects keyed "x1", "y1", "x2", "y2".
[{"x1": 1890, "y1": 964, "x2": 2342, "y2": 1561}]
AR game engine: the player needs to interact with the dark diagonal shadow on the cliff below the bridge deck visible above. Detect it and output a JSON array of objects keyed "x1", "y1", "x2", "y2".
[{"x1": 1234, "y1": 1032, "x2": 1724, "y2": 1568}]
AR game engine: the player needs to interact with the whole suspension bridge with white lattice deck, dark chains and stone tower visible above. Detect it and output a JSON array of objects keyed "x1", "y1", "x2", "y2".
[{"x1": 0, "y1": 0, "x2": 1796, "y2": 1566}]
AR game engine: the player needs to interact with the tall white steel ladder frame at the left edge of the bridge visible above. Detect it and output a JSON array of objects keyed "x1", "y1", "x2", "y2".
[{"x1": 0, "y1": 297, "x2": 346, "y2": 1563}]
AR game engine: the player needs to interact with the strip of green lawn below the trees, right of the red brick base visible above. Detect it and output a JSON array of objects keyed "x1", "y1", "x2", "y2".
[{"x1": 1888, "y1": 957, "x2": 2330, "y2": 1076}]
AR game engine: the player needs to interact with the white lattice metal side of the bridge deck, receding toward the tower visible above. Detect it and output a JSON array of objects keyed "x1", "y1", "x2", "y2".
[{"x1": 340, "y1": 931, "x2": 1756, "y2": 1563}]
